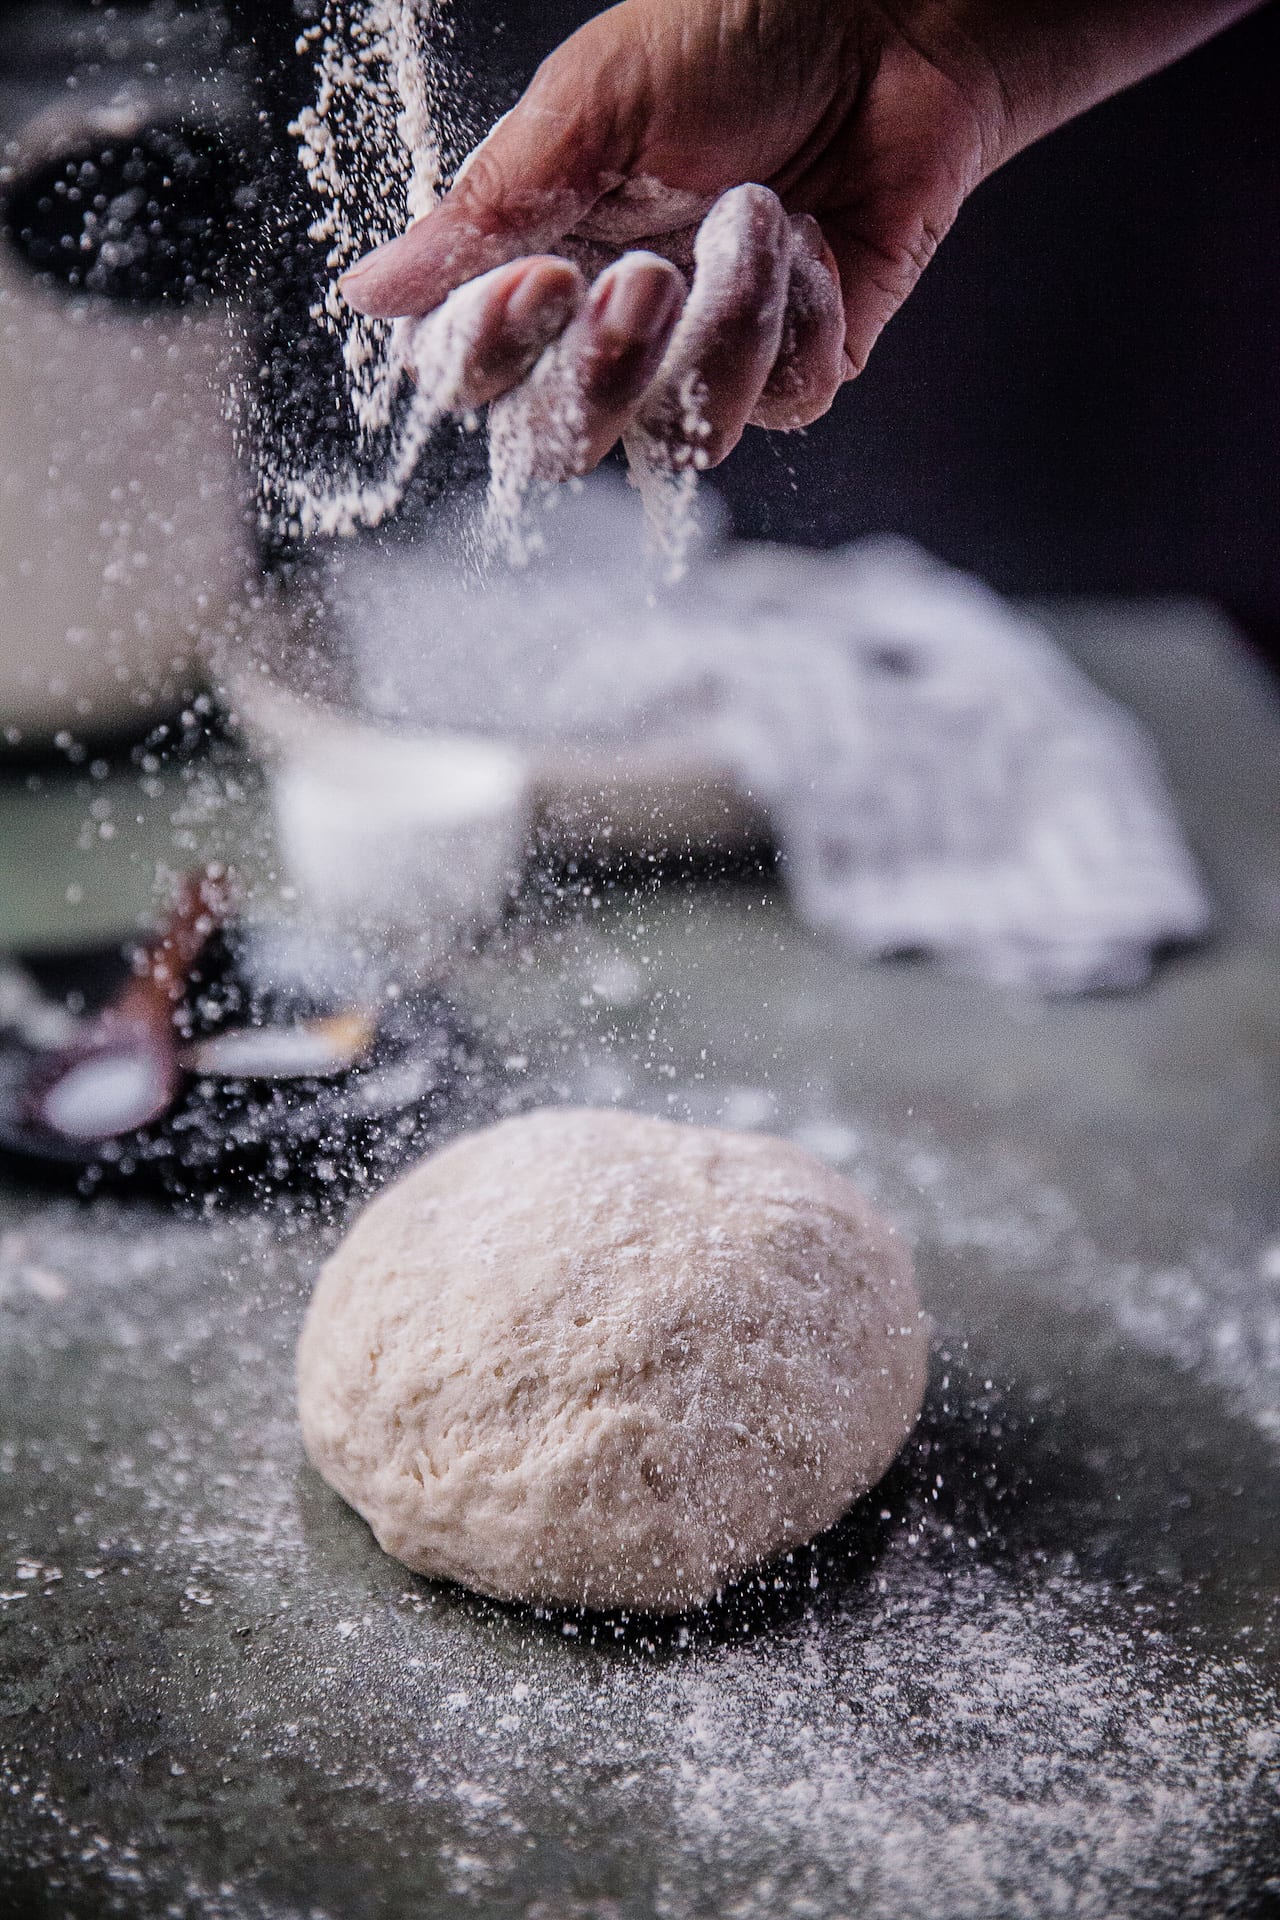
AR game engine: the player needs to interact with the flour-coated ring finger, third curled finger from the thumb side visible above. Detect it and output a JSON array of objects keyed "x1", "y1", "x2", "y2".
[{"x1": 633, "y1": 186, "x2": 793, "y2": 468}]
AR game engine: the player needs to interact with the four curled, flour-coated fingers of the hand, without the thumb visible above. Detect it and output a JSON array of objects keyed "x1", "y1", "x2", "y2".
[{"x1": 379, "y1": 186, "x2": 850, "y2": 482}]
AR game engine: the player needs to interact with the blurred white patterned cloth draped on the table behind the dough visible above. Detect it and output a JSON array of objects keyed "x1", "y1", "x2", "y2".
[{"x1": 336, "y1": 484, "x2": 1211, "y2": 993}]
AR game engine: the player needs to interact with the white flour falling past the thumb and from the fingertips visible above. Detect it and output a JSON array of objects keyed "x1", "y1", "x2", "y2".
[{"x1": 276, "y1": 0, "x2": 706, "y2": 576}]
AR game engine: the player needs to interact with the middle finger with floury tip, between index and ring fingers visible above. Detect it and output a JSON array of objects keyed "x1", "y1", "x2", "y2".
[{"x1": 489, "y1": 253, "x2": 685, "y2": 482}]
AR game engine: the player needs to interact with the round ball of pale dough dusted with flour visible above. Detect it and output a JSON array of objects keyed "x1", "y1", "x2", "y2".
[{"x1": 297, "y1": 1110, "x2": 927, "y2": 1613}]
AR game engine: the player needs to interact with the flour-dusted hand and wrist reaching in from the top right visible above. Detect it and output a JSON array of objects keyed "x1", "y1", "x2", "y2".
[{"x1": 344, "y1": 0, "x2": 1274, "y2": 480}]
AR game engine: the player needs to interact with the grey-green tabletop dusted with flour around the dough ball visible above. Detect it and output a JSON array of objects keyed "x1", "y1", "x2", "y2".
[{"x1": 0, "y1": 607, "x2": 1280, "y2": 1920}]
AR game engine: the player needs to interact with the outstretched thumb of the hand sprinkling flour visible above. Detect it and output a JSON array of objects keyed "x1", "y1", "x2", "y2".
[{"x1": 340, "y1": 23, "x2": 620, "y2": 319}]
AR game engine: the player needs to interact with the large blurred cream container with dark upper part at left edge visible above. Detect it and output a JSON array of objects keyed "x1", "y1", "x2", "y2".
[{"x1": 0, "y1": 8, "x2": 257, "y2": 755}]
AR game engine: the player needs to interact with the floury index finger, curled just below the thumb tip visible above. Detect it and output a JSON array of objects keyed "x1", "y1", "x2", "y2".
[{"x1": 397, "y1": 255, "x2": 587, "y2": 413}]
